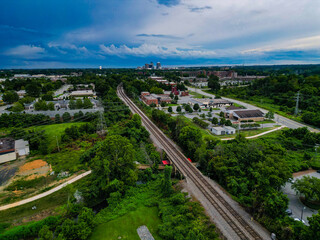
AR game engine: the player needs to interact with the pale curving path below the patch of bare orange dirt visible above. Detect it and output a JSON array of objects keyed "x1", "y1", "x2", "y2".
[{"x1": 0, "y1": 170, "x2": 91, "y2": 211}]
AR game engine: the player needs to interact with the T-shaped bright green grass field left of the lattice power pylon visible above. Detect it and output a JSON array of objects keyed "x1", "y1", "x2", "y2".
[{"x1": 28, "y1": 122, "x2": 84, "y2": 152}]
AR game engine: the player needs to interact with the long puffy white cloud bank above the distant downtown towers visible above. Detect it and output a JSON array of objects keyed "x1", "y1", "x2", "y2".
[{"x1": 100, "y1": 44, "x2": 216, "y2": 58}]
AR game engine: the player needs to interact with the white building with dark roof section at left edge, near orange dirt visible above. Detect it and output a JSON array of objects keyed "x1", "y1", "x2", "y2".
[{"x1": 0, "y1": 138, "x2": 30, "y2": 164}]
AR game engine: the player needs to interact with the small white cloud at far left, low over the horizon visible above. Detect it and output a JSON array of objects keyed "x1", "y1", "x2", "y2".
[{"x1": 4, "y1": 45, "x2": 46, "y2": 59}]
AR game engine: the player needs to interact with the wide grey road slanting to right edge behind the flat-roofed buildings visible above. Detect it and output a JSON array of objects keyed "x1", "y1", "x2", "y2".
[{"x1": 188, "y1": 87, "x2": 320, "y2": 132}]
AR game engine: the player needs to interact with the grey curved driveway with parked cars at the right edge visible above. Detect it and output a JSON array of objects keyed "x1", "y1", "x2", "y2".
[{"x1": 282, "y1": 172, "x2": 320, "y2": 225}]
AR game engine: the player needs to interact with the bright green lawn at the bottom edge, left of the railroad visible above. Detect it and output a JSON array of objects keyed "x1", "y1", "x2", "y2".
[{"x1": 90, "y1": 207, "x2": 161, "y2": 240}]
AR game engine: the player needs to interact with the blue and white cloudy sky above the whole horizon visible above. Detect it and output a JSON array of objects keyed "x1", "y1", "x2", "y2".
[{"x1": 0, "y1": 0, "x2": 320, "y2": 69}]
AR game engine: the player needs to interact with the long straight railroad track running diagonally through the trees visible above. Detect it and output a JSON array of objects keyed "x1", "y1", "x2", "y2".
[{"x1": 117, "y1": 85, "x2": 263, "y2": 240}]
